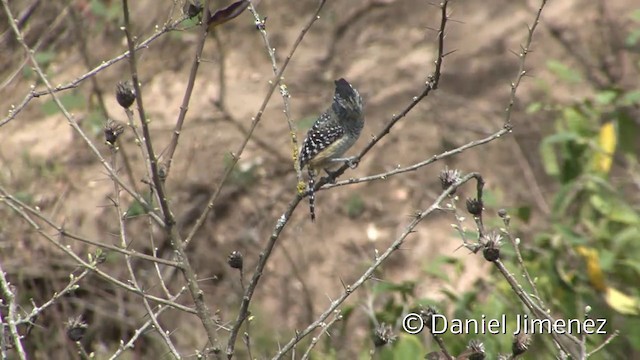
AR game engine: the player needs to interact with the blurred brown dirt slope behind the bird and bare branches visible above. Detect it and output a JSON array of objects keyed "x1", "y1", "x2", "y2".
[{"x1": 0, "y1": 0, "x2": 638, "y2": 359}]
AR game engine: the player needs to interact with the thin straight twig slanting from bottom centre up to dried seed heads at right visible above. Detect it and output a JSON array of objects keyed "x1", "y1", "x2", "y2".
[{"x1": 273, "y1": 173, "x2": 479, "y2": 360}]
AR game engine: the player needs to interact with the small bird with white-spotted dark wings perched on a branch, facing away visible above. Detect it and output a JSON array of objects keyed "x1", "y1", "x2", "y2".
[{"x1": 300, "y1": 78, "x2": 364, "y2": 221}]
